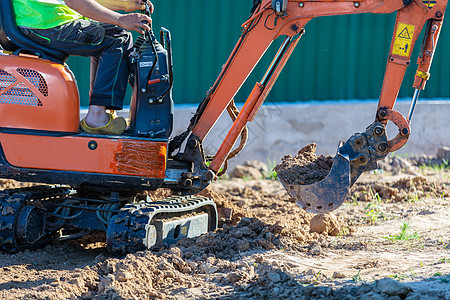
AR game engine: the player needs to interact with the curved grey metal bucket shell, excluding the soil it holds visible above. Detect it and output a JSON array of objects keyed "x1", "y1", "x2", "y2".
[{"x1": 279, "y1": 151, "x2": 351, "y2": 214}]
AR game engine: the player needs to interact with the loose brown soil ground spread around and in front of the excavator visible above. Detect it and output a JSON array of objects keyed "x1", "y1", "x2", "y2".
[{"x1": 0, "y1": 156, "x2": 450, "y2": 300}]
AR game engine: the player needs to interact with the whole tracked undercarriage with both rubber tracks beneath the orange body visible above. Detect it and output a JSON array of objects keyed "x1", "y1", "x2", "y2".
[{"x1": 0, "y1": 185, "x2": 217, "y2": 255}]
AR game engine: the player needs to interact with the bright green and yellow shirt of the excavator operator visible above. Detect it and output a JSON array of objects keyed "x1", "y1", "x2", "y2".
[{"x1": 13, "y1": 0, "x2": 83, "y2": 29}]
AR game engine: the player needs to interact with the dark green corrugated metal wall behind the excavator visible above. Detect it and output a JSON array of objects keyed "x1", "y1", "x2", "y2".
[{"x1": 69, "y1": 0, "x2": 450, "y2": 105}]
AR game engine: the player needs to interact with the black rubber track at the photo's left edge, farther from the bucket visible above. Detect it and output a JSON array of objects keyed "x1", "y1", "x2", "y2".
[{"x1": 0, "y1": 185, "x2": 69, "y2": 253}]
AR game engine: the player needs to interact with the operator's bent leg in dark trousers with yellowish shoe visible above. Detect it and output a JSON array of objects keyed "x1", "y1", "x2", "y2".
[{"x1": 19, "y1": 20, "x2": 132, "y2": 134}]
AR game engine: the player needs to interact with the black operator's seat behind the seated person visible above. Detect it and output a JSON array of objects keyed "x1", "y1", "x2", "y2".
[{"x1": 0, "y1": 0, "x2": 69, "y2": 64}]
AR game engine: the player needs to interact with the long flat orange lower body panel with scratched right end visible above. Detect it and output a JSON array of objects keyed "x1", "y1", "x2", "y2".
[{"x1": 0, "y1": 133, "x2": 167, "y2": 178}]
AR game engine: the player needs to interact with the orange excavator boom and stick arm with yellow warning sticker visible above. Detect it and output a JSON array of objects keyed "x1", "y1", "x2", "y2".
[{"x1": 175, "y1": 0, "x2": 447, "y2": 212}]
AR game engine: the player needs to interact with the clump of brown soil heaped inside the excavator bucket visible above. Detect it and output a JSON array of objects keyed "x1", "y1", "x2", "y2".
[{"x1": 274, "y1": 143, "x2": 333, "y2": 185}]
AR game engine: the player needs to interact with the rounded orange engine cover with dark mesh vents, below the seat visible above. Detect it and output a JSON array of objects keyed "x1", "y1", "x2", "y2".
[{"x1": 0, "y1": 55, "x2": 80, "y2": 132}]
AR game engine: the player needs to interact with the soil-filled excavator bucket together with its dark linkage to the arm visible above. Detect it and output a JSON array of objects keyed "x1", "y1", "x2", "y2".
[{"x1": 275, "y1": 119, "x2": 396, "y2": 213}]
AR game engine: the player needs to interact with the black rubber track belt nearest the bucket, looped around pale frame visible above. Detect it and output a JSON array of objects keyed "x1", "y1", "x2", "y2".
[{"x1": 107, "y1": 196, "x2": 217, "y2": 255}]
